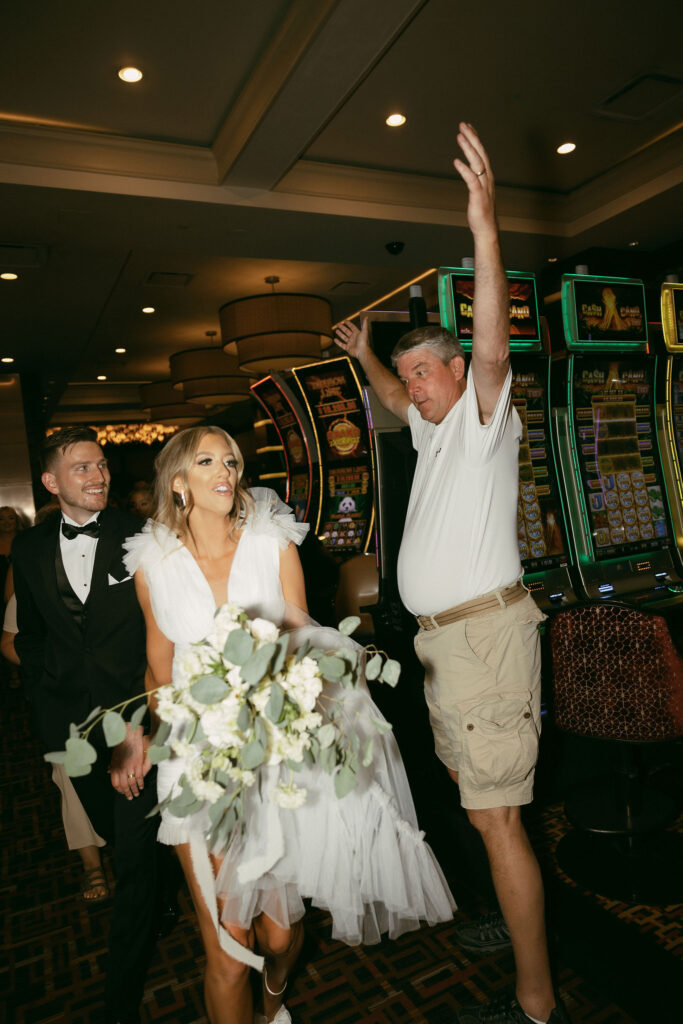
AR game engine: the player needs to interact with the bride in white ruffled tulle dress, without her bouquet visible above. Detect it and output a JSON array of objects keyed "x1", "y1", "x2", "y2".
[{"x1": 126, "y1": 426, "x2": 454, "y2": 1024}]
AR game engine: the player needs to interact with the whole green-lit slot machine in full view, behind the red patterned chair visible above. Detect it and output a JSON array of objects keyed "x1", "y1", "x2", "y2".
[{"x1": 552, "y1": 273, "x2": 681, "y2": 604}]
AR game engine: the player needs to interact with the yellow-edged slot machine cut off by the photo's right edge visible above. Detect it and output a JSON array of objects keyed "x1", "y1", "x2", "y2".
[{"x1": 657, "y1": 281, "x2": 683, "y2": 571}]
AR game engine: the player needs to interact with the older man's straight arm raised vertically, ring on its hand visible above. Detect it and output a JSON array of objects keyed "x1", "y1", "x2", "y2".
[{"x1": 454, "y1": 121, "x2": 510, "y2": 423}]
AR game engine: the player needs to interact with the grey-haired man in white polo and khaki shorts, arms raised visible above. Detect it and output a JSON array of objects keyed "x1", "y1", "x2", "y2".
[{"x1": 337, "y1": 122, "x2": 567, "y2": 1024}]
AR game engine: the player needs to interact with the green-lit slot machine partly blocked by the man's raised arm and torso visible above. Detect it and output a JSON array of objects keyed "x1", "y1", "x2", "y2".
[{"x1": 438, "y1": 267, "x2": 578, "y2": 611}]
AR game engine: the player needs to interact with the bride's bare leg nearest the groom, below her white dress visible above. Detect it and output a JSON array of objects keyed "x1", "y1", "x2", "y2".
[{"x1": 175, "y1": 843, "x2": 254, "y2": 1024}]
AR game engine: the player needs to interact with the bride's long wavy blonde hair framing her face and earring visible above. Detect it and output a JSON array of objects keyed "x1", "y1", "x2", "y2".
[{"x1": 154, "y1": 426, "x2": 253, "y2": 537}]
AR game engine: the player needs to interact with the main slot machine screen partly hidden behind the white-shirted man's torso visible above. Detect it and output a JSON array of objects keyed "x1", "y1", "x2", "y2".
[{"x1": 512, "y1": 356, "x2": 567, "y2": 572}]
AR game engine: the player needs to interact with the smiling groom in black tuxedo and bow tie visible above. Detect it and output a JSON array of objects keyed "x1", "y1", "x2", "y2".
[{"x1": 12, "y1": 427, "x2": 159, "y2": 1024}]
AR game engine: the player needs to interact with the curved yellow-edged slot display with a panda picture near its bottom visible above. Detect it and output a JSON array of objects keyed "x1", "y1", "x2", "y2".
[{"x1": 292, "y1": 356, "x2": 375, "y2": 557}]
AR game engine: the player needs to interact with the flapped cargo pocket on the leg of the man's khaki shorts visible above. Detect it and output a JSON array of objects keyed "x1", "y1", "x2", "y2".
[{"x1": 461, "y1": 693, "x2": 539, "y2": 790}]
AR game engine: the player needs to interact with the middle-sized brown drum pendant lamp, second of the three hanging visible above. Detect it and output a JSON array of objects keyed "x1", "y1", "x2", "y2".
[{"x1": 169, "y1": 347, "x2": 251, "y2": 406}]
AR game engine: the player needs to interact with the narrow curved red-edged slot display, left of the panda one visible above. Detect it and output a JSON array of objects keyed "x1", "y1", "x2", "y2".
[{"x1": 251, "y1": 375, "x2": 319, "y2": 522}]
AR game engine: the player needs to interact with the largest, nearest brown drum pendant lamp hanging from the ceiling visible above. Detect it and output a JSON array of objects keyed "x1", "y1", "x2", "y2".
[{"x1": 218, "y1": 292, "x2": 332, "y2": 374}]
